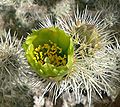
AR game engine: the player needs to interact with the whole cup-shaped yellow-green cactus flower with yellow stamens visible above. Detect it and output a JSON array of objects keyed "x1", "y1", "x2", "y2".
[{"x1": 23, "y1": 27, "x2": 73, "y2": 81}]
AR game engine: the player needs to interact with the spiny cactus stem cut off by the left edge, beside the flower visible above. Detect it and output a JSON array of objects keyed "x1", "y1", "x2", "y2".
[{"x1": 0, "y1": 31, "x2": 22, "y2": 95}]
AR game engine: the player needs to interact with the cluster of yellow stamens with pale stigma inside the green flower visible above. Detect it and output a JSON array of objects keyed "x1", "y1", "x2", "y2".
[{"x1": 33, "y1": 41, "x2": 67, "y2": 66}]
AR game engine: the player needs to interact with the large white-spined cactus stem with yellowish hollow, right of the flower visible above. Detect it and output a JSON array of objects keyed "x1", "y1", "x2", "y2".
[{"x1": 60, "y1": 6, "x2": 120, "y2": 106}]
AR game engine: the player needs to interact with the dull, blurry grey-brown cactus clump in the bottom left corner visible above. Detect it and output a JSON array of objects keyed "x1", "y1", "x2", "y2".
[{"x1": 0, "y1": 86, "x2": 34, "y2": 107}]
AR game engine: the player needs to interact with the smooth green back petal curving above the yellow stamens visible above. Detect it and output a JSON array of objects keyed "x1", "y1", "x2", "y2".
[{"x1": 30, "y1": 27, "x2": 70, "y2": 52}]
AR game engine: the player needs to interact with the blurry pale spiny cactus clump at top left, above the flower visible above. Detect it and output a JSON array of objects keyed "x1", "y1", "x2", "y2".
[{"x1": 16, "y1": 2, "x2": 47, "y2": 28}]
